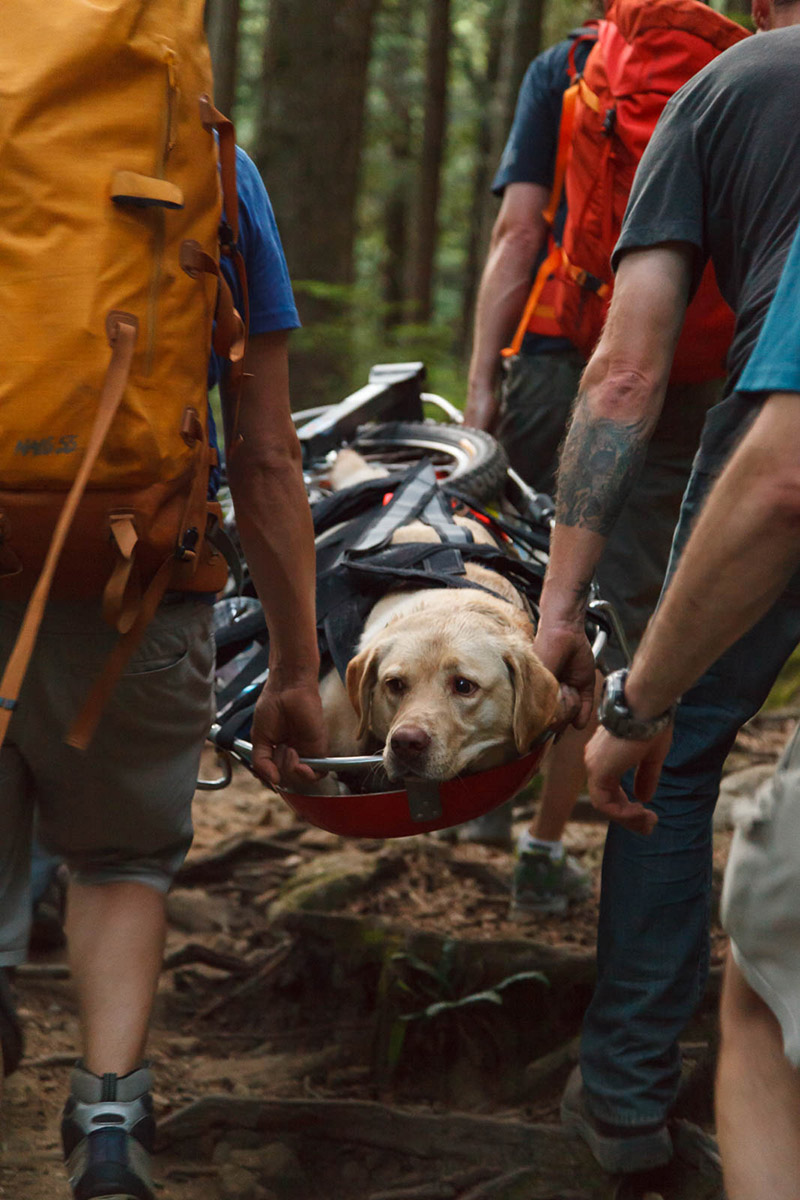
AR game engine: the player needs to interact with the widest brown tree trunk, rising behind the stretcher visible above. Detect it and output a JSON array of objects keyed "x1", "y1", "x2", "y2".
[{"x1": 254, "y1": 0, "x2": 378, "y2": 407}]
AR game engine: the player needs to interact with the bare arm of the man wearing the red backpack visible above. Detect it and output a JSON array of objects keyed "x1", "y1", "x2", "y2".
[{"x1": 464, "y1": 184, "x2": 549, "y2": 430}]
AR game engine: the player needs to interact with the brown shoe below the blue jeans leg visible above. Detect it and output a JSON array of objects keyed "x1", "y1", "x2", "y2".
[{"x1": 561, "y1": 1067, "x2": 673, "y2": 1175}]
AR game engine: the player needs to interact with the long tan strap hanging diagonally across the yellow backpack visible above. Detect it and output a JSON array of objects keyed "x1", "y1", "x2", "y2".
[{"x1": 0, "y1": 312, "x2": 139, "y2": 745}]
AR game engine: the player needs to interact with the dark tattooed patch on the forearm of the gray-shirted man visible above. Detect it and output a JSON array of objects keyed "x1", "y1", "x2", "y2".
[{"x1": 555, "y1": 391, "x2": 651, "y2": 538}]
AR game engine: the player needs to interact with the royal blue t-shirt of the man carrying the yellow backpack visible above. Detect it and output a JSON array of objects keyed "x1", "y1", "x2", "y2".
[{"x1": 209, "y1": 146, "x2": 300, "y2": 499}]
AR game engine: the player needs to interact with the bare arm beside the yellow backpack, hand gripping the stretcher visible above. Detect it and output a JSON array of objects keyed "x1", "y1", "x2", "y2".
[{"x1": 228, "y1": 332, "x2": 325, "y2": 784}]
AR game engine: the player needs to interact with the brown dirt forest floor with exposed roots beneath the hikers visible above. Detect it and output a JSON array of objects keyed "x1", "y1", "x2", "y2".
[{"x1": 0, "y1": 712, "x2": 796, "y2": 1200}]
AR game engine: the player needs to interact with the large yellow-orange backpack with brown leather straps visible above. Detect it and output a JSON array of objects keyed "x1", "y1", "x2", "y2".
[{"x1": 0, "y1": 0, "x2": 245, "y2": 746}]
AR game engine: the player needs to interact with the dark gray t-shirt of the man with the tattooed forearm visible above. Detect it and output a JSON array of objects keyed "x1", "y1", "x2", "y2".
[{"x1": 612, "y1": 26, "x2": 800, "y2": 403}]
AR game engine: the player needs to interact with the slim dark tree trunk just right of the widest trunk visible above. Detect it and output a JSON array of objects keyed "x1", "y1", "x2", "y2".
[{"x1": 410, "y1": 0, "x2": 450, "y2": 322}]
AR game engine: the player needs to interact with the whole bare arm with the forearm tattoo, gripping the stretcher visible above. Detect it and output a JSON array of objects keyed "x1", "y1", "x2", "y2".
[{"x1": 536, "y1": 244, "x2": 691, "y2": 726}]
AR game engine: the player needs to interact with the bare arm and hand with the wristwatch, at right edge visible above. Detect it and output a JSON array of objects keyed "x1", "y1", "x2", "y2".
[{"x1": 587, "y1": 392, "x2": 800, "y2": 833}]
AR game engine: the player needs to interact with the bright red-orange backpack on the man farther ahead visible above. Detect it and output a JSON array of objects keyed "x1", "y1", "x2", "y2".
[{"x1": 504, "y1": 0, "x2": 748, "y2": 383}]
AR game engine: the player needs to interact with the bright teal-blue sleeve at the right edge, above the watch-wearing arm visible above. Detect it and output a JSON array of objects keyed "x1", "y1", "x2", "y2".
[{"x1": 736, "y1": 218, "x2": 800, "y2": 391}]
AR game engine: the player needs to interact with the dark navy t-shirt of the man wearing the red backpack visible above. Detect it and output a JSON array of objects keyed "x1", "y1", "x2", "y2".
[{"x1": 492, "y1": 29, "x2": 594, "y2": 354}]
